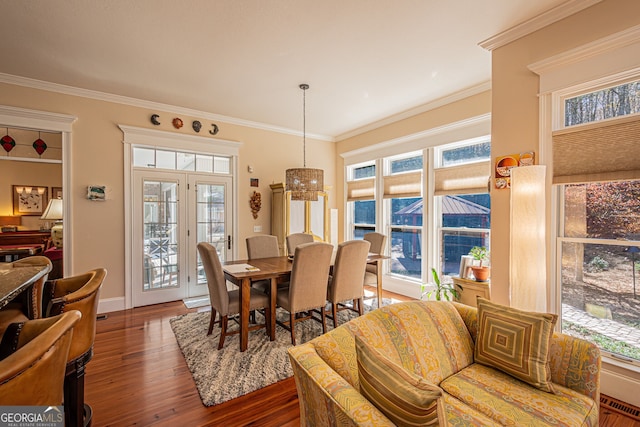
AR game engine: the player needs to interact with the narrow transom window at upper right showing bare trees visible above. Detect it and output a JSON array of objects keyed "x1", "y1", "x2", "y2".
[{"x1": 564, "y1": 80, "x2": 640, "y2": 126}]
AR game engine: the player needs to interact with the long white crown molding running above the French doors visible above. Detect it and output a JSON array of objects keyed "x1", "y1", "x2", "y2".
[{"x1": 0, "y1": 73, "x2": 334, "y2": 142}]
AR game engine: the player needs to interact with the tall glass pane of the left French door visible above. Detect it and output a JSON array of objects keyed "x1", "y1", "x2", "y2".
[{"x1": 142, "y1": 180, "x2": 178, "y2": 291}]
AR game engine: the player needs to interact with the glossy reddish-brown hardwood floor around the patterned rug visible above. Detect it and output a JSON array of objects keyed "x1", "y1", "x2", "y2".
[{"x1": 85, "y1": 294, "x2": 640, "y2": 427}]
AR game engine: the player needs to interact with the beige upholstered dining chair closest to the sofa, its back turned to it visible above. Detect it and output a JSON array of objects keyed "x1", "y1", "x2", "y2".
[{"x1": 276, "y1": 242, "x2": 333, "y2": 345}]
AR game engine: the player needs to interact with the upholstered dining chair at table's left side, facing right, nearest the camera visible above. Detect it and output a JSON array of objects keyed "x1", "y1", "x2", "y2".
[{"x1": 198, "y1": 242, "x2": 271, "y2": 350}]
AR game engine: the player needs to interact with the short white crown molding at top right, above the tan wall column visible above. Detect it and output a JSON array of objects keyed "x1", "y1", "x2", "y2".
[{"x1": 478, "y1": 0, "x2": 602, "y2": 51}]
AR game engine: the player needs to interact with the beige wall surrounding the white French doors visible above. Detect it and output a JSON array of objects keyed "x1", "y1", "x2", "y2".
[{"x1": 0, "y1": 84, "x2": 335, "y2": 300}]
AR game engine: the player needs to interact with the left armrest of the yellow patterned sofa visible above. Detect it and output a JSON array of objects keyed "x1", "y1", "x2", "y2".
[{"x1": 288, "y1": 343, "x2": 394, "y2": 426}]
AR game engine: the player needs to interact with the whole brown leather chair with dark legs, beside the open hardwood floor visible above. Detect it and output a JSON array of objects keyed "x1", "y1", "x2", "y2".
[{"x1": 42, "y1": 268, "x2": 107, "y2": 426}]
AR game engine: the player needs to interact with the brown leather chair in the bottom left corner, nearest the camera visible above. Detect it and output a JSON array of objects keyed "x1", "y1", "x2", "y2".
[{"x1": 0, "y1": 310, "x2": 82, "y2": 404}]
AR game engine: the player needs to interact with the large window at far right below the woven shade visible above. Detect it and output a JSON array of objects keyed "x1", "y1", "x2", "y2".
[{"x1": 558, "y1": 181, "x2": 640, "y2": 364}]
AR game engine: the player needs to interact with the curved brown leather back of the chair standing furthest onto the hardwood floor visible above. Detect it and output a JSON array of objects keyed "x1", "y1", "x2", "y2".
[{"x1": 43, "y1": 268, "x2": 107, "y2": 361}]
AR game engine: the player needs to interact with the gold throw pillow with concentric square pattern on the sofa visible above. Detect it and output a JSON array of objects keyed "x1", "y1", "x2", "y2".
[{"x1": 475, "y1": 298, "x2": 558, "y2": 393}]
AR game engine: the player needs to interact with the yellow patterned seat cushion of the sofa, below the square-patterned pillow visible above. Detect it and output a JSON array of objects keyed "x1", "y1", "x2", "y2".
[{"x1": 440, "y1": 363, "x2": 598, "y2": 427}]
